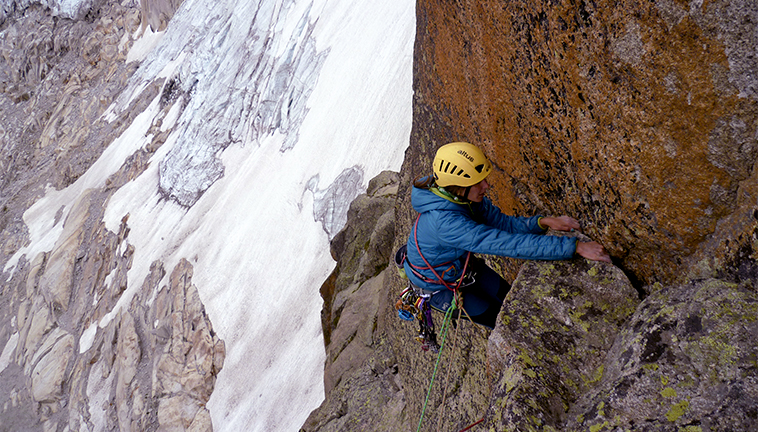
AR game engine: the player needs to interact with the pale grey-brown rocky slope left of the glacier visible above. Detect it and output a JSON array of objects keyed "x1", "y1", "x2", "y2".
[{"x1": 0, "y1": 1, "x2": 225, "y2": 431}]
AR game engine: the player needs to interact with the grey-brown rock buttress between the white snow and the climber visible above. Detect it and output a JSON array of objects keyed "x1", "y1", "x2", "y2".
[{"x1": 302, "y1": 171, "x2": 409, "y2": 431}]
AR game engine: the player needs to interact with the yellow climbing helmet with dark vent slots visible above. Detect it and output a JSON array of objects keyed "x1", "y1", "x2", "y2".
[{"x1": 433, "y1": 142, "x2": 492, "y2": 187}]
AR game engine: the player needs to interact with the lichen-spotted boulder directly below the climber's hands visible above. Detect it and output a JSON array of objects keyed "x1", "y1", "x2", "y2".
[{"x1": 487, "y1": 259, "x2": 639, "y2": 431}]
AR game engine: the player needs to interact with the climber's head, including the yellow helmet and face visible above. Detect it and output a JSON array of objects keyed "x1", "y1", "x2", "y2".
[{"x1": 433, "y1": 142, "x2": 492, "y2": 202}]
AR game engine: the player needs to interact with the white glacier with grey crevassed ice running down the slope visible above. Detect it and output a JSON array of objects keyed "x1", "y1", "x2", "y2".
[{"x1": 0, "y1": 0, "x2": 415, "y2": 431}]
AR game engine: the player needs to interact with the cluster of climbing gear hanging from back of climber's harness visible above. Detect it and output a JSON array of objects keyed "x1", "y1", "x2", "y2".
[{"x1": 395, "y1": 245, "x2": 440, "y2": 353}]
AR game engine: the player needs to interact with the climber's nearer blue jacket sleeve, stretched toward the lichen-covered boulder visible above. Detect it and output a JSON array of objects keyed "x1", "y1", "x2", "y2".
[{"x1": 440, "y1": 212, "x2": 576, "y2": 260}]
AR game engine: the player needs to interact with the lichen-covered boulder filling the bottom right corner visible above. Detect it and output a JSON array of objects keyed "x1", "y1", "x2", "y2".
[{"x1": 566, "y1": 279, "x2": 758, "y2": 432}]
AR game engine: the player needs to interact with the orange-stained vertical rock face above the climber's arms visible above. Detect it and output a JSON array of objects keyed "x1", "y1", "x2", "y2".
[{"x1": 404, "y1": 0, "x2": 758, "y2": 284}]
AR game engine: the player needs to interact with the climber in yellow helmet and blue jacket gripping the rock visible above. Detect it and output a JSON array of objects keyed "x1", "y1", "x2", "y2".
[{"x1": 403, "y1": 142, "x2": 610, "y2": 328}]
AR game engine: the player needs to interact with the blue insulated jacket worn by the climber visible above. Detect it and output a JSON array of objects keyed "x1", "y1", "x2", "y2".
[{"x1": 404, "y1": 187, "x2": 576, "y2": 290}]
